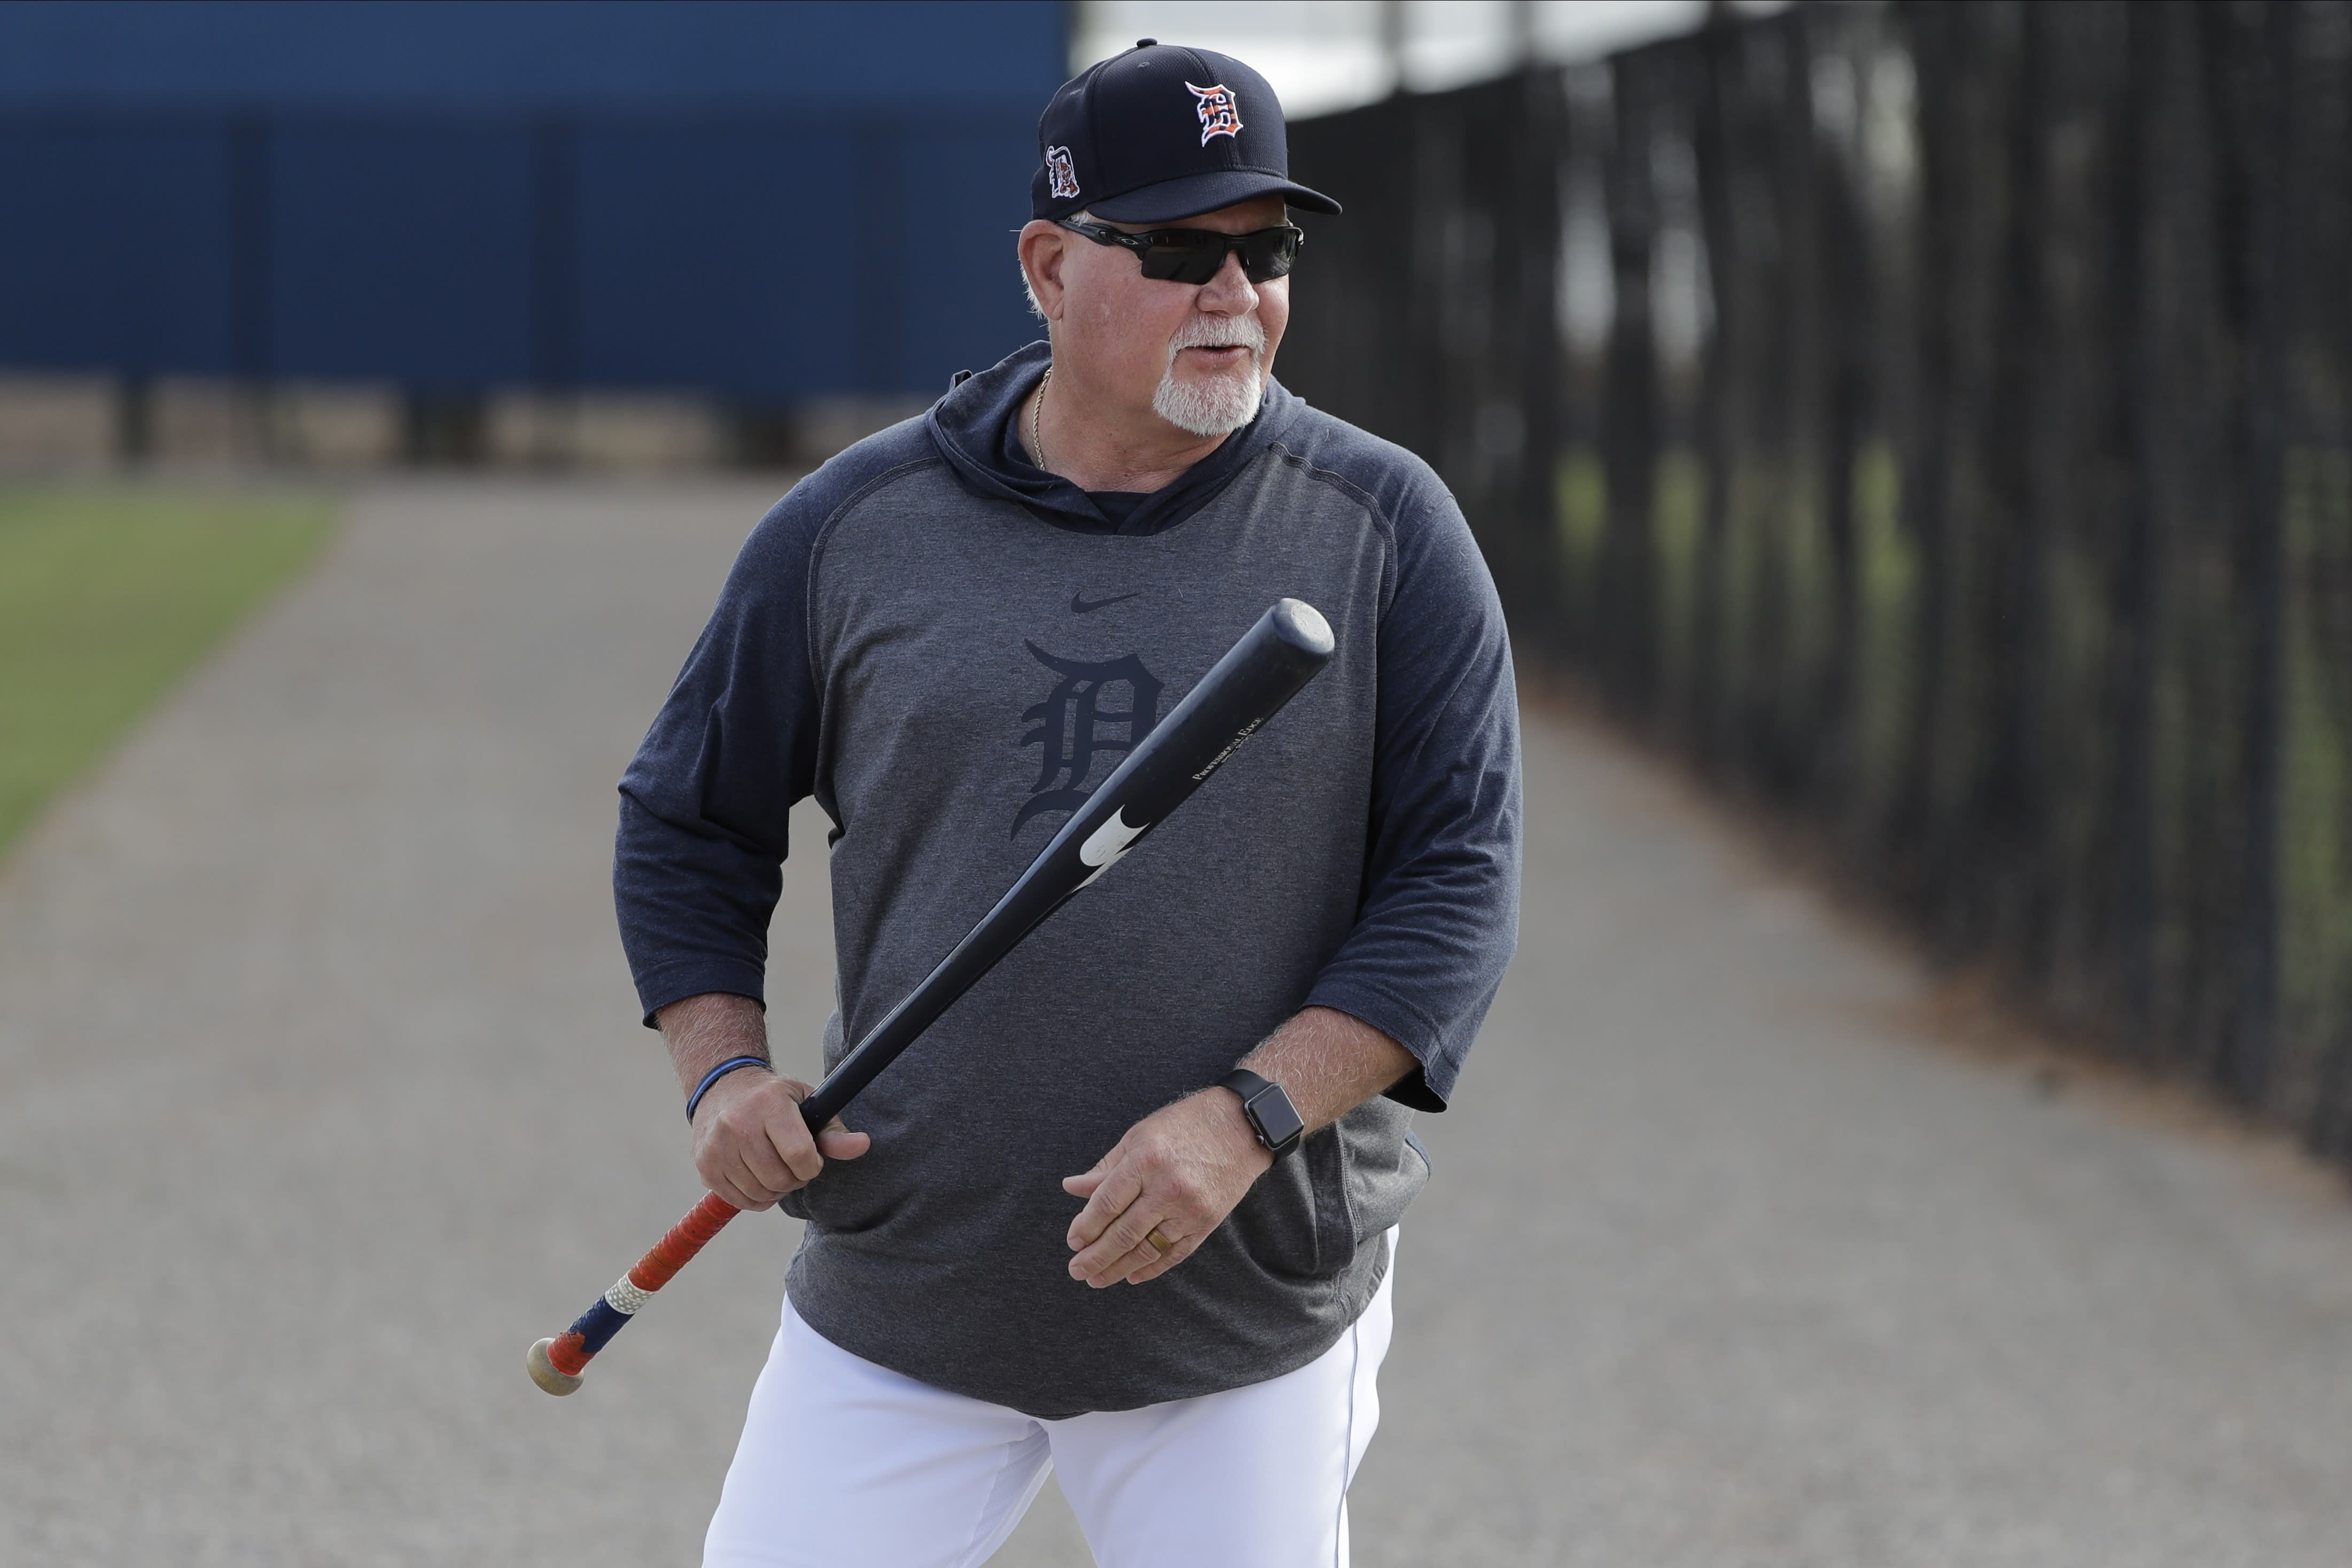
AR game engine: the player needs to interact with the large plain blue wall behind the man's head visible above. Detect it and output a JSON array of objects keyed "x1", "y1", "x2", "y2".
[{"x1": 0, "y1": 0, "x2": 1065, "y2": 402}]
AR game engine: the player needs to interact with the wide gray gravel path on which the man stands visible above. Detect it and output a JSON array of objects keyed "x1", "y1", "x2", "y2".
[{"x1": 0, "y1": 482, "x2": 2352, "y2": 1568}]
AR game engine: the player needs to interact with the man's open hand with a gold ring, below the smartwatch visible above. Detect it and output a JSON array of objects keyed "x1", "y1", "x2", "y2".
[{"x1": 1061, "y1": 1088, "x2": 1275, "y2": 1288}]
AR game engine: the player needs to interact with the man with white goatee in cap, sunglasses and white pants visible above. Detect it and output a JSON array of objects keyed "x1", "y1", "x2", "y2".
[{"x1": 616, "y1": 40, "x2": 1520, "y2": 1568}]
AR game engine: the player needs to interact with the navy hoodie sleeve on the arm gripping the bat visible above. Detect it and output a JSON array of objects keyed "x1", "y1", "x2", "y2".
[{"x1": 612, "y1": 491, "x2": 847, "y2": 1025}]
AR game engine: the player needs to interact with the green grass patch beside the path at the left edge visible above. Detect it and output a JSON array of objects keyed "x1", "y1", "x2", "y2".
[{"x1": 0, "y1": 489, "x2": 334, "y2": 853}]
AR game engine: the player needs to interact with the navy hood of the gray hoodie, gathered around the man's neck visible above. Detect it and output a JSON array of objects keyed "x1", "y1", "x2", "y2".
[{"x1": 924, "y1": 343, "x2": 1305, "y2": 534}]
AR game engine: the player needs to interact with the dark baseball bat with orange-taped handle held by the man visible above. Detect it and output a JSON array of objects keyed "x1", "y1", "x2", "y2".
[{"x1": 527, "y1": 599, "x2": 1336, "y2": 1394}]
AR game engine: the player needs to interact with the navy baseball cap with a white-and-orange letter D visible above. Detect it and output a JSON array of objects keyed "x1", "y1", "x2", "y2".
[{"x1": 1030, "y1": 37, "x2": 1338, "y2": 223}]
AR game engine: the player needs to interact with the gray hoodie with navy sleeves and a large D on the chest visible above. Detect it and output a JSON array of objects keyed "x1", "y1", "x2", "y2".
[{"x1": 614, "y1": 343, "x2": 1520, "y2": 1417}]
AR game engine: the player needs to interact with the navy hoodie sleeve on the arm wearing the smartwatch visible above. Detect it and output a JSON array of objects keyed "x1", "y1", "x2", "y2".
[{"x1": 1308, "y1": 458, "x2": 1520, "y2": 1110}]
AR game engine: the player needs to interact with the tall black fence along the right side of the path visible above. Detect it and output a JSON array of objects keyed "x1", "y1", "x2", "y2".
[{"x1": 1282, "y1": 0, "x2": 2352, "y2": 1161}]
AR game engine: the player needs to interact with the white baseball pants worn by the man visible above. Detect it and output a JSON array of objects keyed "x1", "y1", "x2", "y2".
[{"x1": 703, "y1": 1232, "x2": 1395, "y2": 1568}]
